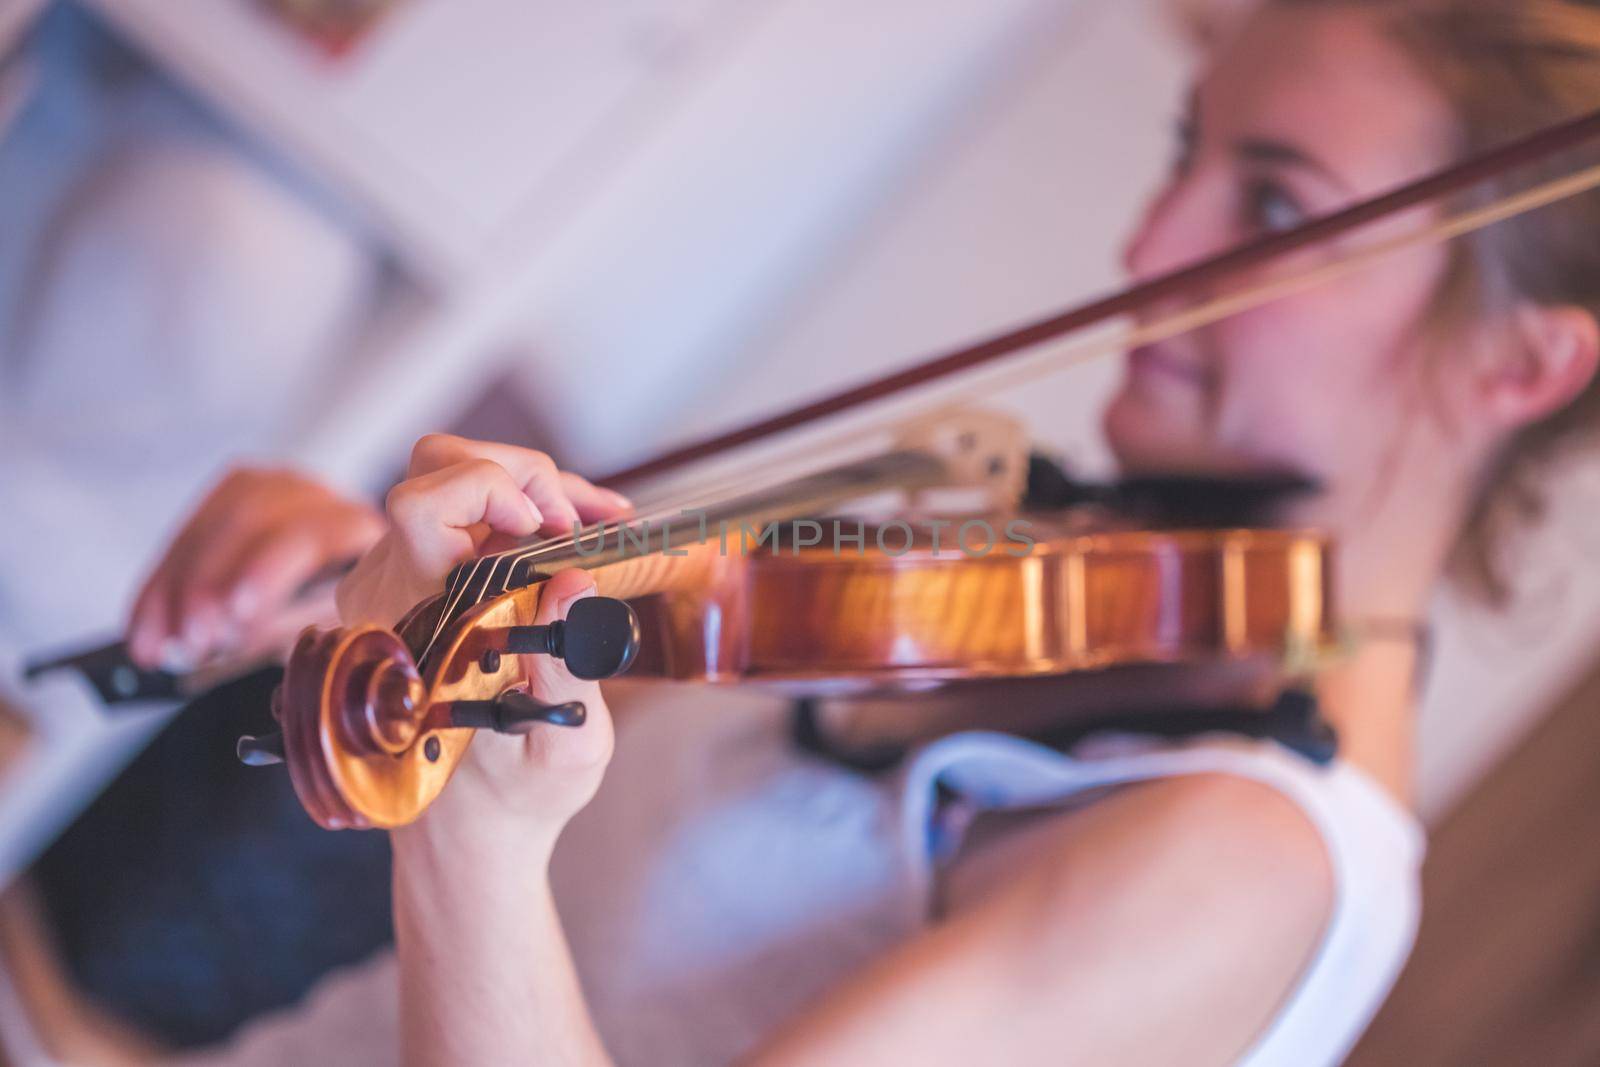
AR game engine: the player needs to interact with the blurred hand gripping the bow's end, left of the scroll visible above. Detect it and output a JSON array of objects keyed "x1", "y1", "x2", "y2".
[{"x1": 126, "y1": 467, "x2": 384, "y2": 669}]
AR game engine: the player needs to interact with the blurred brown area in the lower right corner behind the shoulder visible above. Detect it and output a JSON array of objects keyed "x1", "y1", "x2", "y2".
[{"x1": 1347, "y1": 652, "x2": 1600, "y2": 1067}]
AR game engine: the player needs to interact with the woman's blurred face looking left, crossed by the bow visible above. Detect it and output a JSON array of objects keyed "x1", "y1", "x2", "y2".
[{"x1": 1106, "y1": 10, "x2": 1454, "y2": 488}]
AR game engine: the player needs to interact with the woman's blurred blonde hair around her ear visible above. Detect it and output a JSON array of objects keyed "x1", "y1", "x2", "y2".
[{"x1": 1267, "y1": 0, "x2": 1600, "y2": 601}]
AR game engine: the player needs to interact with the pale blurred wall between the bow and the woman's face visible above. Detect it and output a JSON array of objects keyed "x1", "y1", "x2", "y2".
[{"x1": 649, "y1": 0, "x2": 1164, "y2": 466}]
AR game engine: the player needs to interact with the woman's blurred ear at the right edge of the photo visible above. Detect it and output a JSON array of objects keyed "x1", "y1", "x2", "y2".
[{"x1": 1478, "y1": 304, "x2": 1600, "y2": 430}]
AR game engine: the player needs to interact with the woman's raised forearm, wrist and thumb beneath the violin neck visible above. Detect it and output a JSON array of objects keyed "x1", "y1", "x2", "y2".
[{"x1": 389, "y1": 571, "x2": 611, "y2": 1067}]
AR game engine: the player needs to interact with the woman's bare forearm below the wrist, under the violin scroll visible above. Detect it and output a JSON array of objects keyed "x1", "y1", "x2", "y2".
[{"x1": 394, "y1": 819, "x2": 611, "y2": 1067}]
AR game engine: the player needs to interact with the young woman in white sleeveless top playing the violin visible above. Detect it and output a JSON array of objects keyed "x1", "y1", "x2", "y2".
[{"x1": 121, "y1": 0, "x2": 1600, "y2": 1067}]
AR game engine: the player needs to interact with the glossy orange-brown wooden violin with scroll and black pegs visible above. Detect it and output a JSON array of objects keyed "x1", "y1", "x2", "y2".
[{"x1": 272, "y1": 404, "x2": 1336, "y2": 829}]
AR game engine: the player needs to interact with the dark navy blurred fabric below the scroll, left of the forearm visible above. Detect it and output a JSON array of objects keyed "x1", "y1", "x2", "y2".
[{"x1": 34, "y1": 670, "x2": 392, "y2": 1048}]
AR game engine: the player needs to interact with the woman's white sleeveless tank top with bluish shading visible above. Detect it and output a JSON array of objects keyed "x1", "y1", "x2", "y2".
[{"x1": 182, "y1": 701, "x2": 1422, "y2": 1067}]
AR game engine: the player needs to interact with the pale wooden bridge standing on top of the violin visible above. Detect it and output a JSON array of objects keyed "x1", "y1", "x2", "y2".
[{"x1": 896, "y1": 408, "x2": 1029, "y2": 512}]
